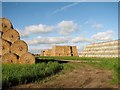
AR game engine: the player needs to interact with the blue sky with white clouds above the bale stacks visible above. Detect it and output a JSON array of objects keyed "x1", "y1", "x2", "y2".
[{"x1": 2, "y1": 2, "x2": 118, "y2": 54}]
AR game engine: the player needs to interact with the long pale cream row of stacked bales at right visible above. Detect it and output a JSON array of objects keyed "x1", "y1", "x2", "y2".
[{"x1": 79, "y1": 40, "x2": 120, "y2": 58}]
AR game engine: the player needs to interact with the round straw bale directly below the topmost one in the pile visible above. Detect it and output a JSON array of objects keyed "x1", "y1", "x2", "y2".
[{"x1": 2, "y1": 29, "x2": 20, "y2": 43}]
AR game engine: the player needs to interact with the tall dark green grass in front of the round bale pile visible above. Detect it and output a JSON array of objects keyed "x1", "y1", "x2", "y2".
[{"x1": 2, "y1": 62, "x2": 62, "y2": 88}]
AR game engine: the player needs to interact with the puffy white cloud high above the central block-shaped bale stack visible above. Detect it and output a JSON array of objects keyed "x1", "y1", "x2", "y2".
[{"x1": 57, "y1": 20, "x2": 78, "y2": 35}]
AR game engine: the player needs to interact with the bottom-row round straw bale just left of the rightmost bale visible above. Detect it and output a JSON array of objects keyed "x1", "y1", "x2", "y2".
[{"x1": 2, "y1": 53, "x2": 18, "y2": 63}]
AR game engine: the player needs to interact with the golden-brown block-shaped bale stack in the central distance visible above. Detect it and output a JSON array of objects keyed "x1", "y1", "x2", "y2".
[{"x1": 41, "y1": 46, "x2": 78, "y2": 56}]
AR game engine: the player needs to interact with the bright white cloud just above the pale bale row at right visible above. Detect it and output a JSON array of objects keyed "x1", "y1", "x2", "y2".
[{"x1": 91, "y1": 30, "x2": 113, "y2": 41}]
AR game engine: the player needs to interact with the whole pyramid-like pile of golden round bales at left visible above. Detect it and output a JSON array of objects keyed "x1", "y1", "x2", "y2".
[{"x1": 0, "y1": 18, "x2": 35, "y2": 64}]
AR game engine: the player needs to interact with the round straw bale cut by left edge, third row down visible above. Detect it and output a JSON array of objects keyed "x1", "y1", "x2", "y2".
[{"x1": 0, "y1": 38, "x2": 10, "y2": 55}]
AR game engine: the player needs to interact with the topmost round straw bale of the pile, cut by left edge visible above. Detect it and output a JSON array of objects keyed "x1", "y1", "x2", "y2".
[{"x1": 0, "y1": 18, "x2": 13, "y2": 30}]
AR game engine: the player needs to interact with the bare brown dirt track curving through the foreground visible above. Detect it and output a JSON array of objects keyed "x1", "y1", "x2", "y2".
[{"x1": 12, "y1": 63, "x2": 118, "y2": 88}]
